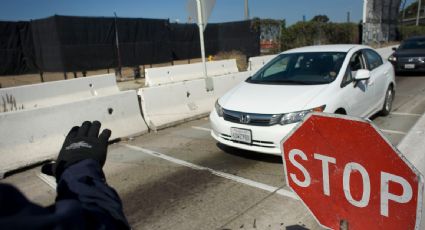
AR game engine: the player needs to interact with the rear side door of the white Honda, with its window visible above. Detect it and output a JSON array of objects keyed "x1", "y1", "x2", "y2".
[{"x1": 363, "y1": 49, "x2": 389, "y2": 108}]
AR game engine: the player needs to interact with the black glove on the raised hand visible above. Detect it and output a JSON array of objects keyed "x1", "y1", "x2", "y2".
[{"x1": 41, "y1": 121, "x2": 111, "y2": 180}]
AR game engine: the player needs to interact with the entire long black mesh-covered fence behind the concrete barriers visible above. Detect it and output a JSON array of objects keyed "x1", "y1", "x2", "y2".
[{"x1": 0, "y1": 15, "x2": 260, "y2": 75}]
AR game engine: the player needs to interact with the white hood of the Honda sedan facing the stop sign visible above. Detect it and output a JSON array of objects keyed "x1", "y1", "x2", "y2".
[{"x1": 219, "y1": 82, "x2": 329, "y2": 114}]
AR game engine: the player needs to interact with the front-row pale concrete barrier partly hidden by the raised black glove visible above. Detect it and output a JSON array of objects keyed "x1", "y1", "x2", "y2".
[{"x1": 0, "y1": 91, "x2": 148, "y2": 178}]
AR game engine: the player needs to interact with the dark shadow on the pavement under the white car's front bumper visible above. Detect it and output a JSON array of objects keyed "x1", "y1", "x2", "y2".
[{"x1": 217, "y1": 143, "x2": 282, "y2": 164}]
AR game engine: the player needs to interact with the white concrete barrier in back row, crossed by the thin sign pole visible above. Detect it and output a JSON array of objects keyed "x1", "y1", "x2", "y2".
[{"x1": 145, "y1": 59, "x2": 238, "y2": 86}]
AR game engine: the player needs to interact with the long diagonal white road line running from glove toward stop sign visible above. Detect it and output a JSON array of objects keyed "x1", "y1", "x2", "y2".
[{"x1": 120, "y1": 144, "x2": 299, "y2": 200}]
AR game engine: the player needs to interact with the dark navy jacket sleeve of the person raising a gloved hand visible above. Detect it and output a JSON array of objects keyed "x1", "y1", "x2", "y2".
[{"x1": 0, "y1": 160, "x2": 130, "y2": 230}]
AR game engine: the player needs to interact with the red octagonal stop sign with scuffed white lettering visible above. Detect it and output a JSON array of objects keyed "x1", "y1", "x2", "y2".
[{"x1": 281, "y1": 114, "x2": 425, "y2": 230}]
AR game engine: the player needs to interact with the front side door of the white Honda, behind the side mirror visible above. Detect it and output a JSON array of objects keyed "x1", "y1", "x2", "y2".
[{"x1": 341, "y1": 51, "x2": 374, "y2": 117}]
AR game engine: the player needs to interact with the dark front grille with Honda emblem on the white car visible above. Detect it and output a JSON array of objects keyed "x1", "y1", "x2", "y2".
[{"x1": 223, "y1": 109, "x2": 279, "y2": 126}]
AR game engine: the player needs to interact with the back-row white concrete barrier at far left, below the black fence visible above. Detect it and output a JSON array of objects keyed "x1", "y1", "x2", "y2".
[{"x1": 0, "y1": 74, "x2": 119, "y2": 113}]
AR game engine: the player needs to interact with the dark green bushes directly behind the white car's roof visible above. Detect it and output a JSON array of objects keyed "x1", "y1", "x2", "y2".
[{"x1": 281, "y1": 21, "x2": 359, "y2": 50}]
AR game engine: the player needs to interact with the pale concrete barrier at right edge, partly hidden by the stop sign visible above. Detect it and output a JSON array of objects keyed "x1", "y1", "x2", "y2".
[{"x1": 398, "y1": 114, "x2": 425, "y2": 229}]
